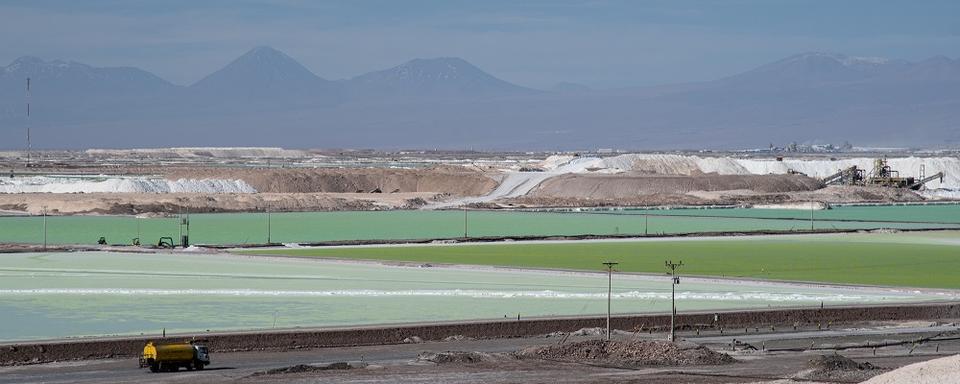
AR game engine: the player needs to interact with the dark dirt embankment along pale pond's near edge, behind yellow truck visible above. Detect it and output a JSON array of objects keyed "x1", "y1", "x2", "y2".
[{"x1": 0, "y1": 303, "x2": 960, "y2": 365}]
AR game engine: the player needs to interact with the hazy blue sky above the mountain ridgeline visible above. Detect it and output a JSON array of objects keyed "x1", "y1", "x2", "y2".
[{"x1": 0, "y1": 0, "x2": 960, "y2": 88}]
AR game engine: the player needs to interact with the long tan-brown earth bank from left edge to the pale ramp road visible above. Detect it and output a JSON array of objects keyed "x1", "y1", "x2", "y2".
[{"x1": 0, "y1": 167, "x2": 497, "y2": 215}]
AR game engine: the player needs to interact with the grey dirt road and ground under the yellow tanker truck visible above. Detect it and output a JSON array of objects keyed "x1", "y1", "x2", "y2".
[{"x1": 0, "y1": 322, "x2": 960, "y2": 384}]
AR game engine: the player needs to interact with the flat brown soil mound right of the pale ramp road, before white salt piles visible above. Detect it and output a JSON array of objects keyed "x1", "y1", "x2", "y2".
[{"x1": 530, "y1": 174, "x2": 823, "y2": 199}]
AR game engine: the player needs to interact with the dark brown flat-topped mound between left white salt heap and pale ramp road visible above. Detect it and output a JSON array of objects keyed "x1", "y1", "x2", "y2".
[{"x1": 164, "y1": 167, "x2": 497, "y2": 196}]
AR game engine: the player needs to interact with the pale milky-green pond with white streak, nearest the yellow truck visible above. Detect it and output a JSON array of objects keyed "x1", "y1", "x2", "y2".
[{"x1": 0, "y1": 252, "x2": 947, "y2": 340}]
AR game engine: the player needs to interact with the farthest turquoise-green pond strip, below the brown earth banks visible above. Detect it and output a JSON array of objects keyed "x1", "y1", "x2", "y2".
[{"x1": 0, "y1": 205, "x2": 960, "y2": 244}]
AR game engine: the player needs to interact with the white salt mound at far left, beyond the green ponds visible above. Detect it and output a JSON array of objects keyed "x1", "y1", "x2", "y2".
[{"x1": 0, "y1": 176, "x2": 257, "y2": 193}]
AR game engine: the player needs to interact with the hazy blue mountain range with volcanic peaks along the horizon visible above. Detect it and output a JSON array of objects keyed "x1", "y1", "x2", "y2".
[{"x1": 0, "y1": 47, "x2": 960, "y2": 150}]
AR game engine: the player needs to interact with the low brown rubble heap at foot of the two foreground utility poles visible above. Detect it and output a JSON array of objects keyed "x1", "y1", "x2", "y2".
[{"x1": 517, "y1": 340, "x2": 734, "y2": 367}]
